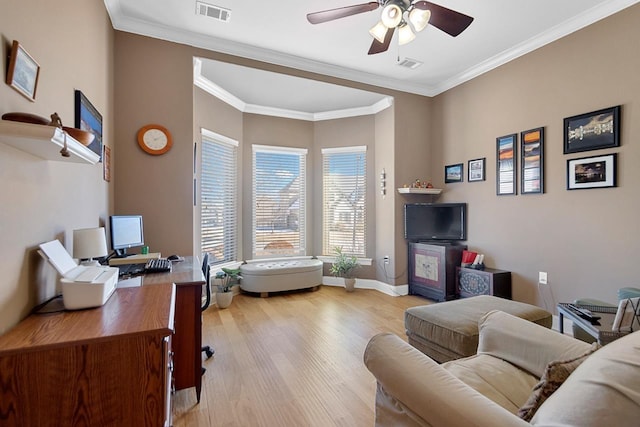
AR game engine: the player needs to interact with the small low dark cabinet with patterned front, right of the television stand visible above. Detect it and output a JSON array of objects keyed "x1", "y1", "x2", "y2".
[{"x1": 456, "y1": 267, "x2": 511, "y2": 299}]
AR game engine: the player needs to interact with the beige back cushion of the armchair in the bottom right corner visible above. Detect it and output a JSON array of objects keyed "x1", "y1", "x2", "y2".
[{"x1": 531, "y1": 331, "x2": 640, "y2": 427}]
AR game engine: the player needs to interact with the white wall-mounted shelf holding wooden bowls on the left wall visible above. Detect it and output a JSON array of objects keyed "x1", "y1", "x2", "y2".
[{"x1": 0, "y1": 120, "x2": 100, "y2": 165}]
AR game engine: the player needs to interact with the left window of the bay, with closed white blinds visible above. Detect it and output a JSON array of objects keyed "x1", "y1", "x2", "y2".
[{"x1": 200, "y1": 129, "x2": 238, "y2": 264}]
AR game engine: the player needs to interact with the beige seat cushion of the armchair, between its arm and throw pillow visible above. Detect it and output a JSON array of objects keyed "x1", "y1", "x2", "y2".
[{"x1": 442, "y1": 354, "x2": 538, "y2": 414}]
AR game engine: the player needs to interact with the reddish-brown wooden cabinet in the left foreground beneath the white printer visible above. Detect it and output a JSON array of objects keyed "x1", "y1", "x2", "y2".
[{"x1": 0, "y1": 284, "x2": 175, "y2": 427}]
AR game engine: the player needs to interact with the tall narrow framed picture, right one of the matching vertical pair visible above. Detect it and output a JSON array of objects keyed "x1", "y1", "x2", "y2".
[{"x1": 520, "y1": 128, "x2": 544, "y2": 194}]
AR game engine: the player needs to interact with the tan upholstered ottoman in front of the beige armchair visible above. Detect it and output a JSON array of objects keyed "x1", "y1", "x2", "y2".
[{"x1": 404, "y1": 295, "x2": 553, "y2": 363}]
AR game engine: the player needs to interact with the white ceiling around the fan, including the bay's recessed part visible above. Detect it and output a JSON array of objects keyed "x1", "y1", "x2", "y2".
[{"x1": 104, "y1": 0, "x2": 640, "y2": 114}]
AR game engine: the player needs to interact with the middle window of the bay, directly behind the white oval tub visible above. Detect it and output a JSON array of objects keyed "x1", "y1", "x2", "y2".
[{"x1": 253, "y1": 145, "x2": 307, "y2": 258}]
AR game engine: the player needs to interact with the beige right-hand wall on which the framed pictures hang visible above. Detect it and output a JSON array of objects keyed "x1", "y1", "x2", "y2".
[{"x1": 431, "y1": 5, "x2": 640, "y2": 304}]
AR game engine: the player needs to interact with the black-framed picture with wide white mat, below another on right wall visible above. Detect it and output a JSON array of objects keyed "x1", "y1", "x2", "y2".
[{"x1": 567, "y1": 153, "x2": 618, "y2": 190}]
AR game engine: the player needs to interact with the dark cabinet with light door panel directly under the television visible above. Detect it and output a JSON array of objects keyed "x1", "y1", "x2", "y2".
[{"x1": 409, "y1": 242, "x2": 467, "y2": 301}]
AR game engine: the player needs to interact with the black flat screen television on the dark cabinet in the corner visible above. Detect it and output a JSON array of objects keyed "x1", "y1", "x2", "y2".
[{"x1": 404, "y1": 203, "x2": 467, "y2": 241}]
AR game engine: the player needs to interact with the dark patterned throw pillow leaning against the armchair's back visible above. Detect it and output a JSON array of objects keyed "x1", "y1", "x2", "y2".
[{"x1": 518, "y1": 342, "x2": 600, "y2": 421}]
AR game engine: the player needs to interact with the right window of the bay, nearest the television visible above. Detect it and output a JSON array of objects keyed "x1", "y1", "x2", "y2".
[{"x1": 322, "y1": 146, "x2": 367, "y2": 257}]
